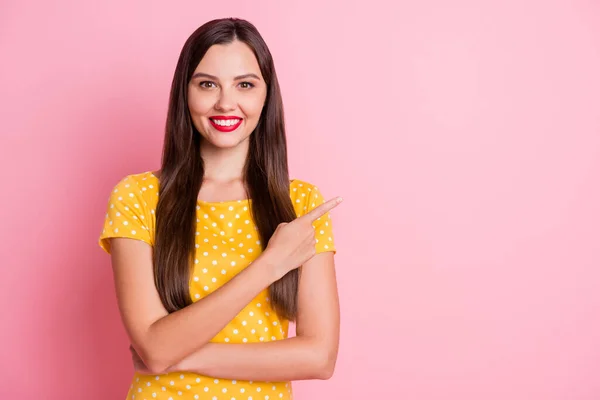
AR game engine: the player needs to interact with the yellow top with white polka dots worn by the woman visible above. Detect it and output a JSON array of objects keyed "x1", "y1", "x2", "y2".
[{"x1": 99, "y1": 171, "x2": 336, "y2": 400}]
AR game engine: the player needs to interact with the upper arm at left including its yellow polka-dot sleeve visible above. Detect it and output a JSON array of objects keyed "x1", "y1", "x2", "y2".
[{"x1": 98, "y1": 177, "x2": 168, "y2": 358}]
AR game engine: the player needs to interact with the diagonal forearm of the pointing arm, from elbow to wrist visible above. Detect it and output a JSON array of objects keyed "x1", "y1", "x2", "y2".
[{"x1": 140, "y1": 257, "x2": 271, "y2": 373}]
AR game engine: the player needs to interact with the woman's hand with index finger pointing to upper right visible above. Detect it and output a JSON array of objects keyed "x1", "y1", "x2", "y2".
[{"x1": 262, "y1": 197, "x2": 342, "y2": 280}]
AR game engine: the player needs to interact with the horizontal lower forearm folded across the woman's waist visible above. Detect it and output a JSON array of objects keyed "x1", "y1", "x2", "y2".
[{"x1": 171, "y1": 336, "x2": 337, "y2": 381}]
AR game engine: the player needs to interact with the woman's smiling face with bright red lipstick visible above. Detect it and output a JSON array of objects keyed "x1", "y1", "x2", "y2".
[{"x1": 188, "y1": 40, "x2": 267, "y2": 148}]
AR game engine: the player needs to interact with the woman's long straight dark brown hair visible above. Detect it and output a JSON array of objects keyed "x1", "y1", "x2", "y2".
[{"x1": 153, "y1": 18, "x2": 299, "y2": 320}]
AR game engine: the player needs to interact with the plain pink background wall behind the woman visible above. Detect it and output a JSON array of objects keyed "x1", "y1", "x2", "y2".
[{"x1": 0, "y1": 0, "x2": 600, "y2": 400}]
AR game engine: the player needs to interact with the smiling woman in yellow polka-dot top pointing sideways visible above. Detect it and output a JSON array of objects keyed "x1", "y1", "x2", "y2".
[{"x1": 99, "y1": 18, "x2": 341, "y2": 400}]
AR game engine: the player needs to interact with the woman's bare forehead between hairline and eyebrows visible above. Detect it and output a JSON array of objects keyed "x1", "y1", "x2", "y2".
[{"x1": 194, "y1": 40, "x2": 262, "y2": 79}]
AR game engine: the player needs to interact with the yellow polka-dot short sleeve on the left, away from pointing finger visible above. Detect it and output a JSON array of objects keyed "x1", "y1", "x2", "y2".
[{"x1": 98, "y1": 176, "x2": 153, "y2": 254}]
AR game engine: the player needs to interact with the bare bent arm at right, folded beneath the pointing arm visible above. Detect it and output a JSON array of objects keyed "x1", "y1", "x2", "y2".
[{"x1": 167, "y1": 252, "x2": 339, "y2": 381}]
